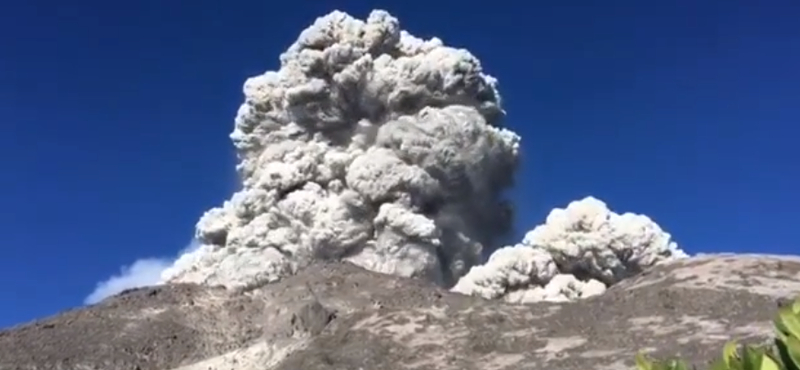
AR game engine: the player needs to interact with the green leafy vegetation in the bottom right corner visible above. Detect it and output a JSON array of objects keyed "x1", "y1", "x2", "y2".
[{"x1": 636, "y1": 297, "x2": 800, "y2": 370}]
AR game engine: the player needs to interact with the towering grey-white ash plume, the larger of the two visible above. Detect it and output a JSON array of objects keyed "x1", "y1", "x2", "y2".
[{"x1": 162, "y1": 11, "x2": 519, "y2": 288}]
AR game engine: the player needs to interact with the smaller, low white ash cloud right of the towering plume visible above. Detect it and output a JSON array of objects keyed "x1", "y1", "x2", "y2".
[{"x1": 452, "y1": 197, "x2": 687, "y2": 303}]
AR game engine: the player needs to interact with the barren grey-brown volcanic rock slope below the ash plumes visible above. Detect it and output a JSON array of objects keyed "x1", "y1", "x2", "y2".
[{"x1": 0, "y1": 255, "x2": 800, "y2": 370}]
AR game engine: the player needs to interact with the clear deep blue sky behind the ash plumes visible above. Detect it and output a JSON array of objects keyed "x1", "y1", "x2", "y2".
[{"x1": 0, "y1": 0, "x2": 800, "y2": 327}]
